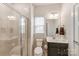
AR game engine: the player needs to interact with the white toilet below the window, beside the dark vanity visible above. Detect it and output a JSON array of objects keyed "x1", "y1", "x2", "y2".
[{"x1": 34, "y1": 39, "x2": 43, "y2": 56}]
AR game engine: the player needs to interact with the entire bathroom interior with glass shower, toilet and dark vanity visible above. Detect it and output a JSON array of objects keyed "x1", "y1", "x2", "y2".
[{"x1": 0, "y1": 3, "x2": 79, "y2": 56}]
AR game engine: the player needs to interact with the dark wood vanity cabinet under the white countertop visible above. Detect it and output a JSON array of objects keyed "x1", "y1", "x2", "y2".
[{"x1": 47, "y1": 42, "x2": 68, "y2": 56}]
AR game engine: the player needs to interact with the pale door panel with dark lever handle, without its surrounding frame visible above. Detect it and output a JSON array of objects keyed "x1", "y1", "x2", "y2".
[{"x1": 74, "y1": 4, "x2": 79, "y2": 56}]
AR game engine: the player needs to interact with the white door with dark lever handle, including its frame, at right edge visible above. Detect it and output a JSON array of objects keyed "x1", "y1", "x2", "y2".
[{"x1": 73, "y1": 3, "x2": 79, "y2": 56}]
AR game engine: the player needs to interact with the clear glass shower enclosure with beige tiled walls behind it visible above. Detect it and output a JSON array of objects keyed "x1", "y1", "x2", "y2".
[{"x1": 0, "y1": 4, "x2": 27, "y2": 56}]
